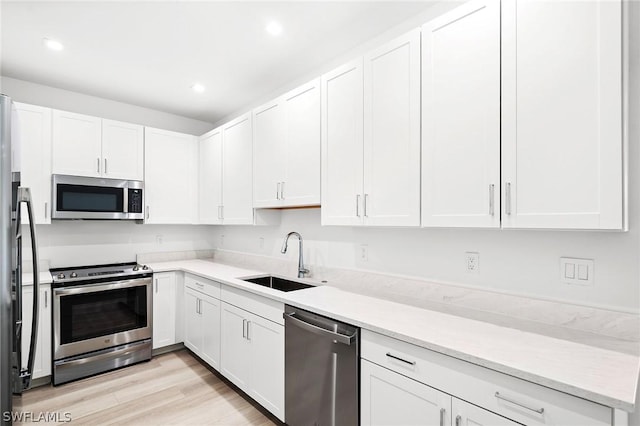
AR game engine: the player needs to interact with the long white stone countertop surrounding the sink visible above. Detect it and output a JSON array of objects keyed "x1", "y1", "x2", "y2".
[{"x1": 149, "y1": 260, "x2": 640, "y2": 412}]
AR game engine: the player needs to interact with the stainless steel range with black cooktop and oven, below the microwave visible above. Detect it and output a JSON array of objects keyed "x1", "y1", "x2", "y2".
[{"x1": 52, "y1": 263, "x2": 153, "y2": 385}]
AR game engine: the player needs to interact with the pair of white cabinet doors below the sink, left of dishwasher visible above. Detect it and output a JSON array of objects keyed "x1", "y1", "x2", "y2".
[{"x1": 220, "y1": 302, "x2": 284, "y2": 421}]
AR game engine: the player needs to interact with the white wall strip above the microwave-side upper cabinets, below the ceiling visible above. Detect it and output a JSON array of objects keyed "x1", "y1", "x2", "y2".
[{"x1": 0, "y1": 77, "x2": 213, "y2": 136}]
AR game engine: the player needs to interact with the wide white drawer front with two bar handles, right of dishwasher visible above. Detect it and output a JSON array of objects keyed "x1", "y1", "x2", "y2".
[{"x1": 361, "y1": 330, "x2": 612, "y2": 426}]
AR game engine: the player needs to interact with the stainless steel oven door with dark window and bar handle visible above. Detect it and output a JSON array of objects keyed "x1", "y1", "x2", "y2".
[{"x1": 53, "y1": 277, "x2": 153, "y2": 360}]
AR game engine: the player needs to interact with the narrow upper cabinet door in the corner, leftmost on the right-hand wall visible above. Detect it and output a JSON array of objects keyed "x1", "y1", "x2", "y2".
[{"x1": 198, "y1": 129, "x2": 222, "y2": 225}]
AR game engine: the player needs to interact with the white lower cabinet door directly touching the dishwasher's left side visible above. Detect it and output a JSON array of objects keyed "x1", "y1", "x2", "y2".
[{"x1": 247, "y1": 315, "x2": 284, "y2": 421}]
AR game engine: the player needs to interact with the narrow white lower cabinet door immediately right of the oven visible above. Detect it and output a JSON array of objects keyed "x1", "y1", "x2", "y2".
[{"x1": 153, "y1": 272, "x2": 176, "y2": 349}]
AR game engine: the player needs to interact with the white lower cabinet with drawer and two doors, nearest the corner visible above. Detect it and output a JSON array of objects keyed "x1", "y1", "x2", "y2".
[{"x1": 184, "y1": 275, "x2": 220, "y2": 371}]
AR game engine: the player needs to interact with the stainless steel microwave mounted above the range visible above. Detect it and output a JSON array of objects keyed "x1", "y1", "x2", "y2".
[{"x1": 51, "y1": 175, "x2": 144, "y2": 220}]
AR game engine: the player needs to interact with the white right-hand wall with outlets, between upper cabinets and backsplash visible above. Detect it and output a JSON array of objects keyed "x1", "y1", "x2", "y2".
[{"x1": 208, "y1": 2, "x2": 640, "y2": 312}]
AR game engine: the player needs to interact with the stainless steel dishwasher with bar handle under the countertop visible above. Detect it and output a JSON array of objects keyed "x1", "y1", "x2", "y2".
[{"x1": 284, "y1": 305, "x2": 360, "y2": 426}]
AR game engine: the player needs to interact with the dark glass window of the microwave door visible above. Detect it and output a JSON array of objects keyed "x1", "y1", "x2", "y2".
[{"x1": 56, "y1": 184, "x2": 124, "y2": 213}]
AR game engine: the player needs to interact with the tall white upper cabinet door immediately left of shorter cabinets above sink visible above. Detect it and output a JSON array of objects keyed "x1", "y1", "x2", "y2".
[{"x1": 222, "y1": 114, "x2": 253, "y2": 225}]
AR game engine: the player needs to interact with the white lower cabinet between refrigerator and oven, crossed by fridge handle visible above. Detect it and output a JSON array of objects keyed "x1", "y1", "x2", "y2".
[{"x1": 22, "y1": 284, "x2": 51, "y2": 379}]
